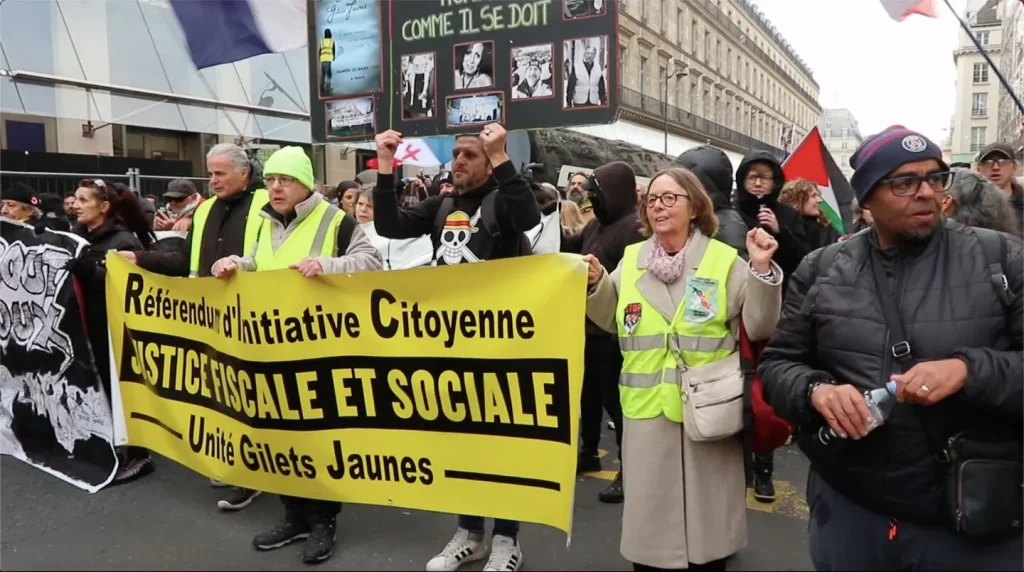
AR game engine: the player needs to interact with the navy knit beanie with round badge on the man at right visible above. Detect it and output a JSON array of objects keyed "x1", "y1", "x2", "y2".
[{"x1": 850, "y1": 125, "x2": 949, "y2": 205}]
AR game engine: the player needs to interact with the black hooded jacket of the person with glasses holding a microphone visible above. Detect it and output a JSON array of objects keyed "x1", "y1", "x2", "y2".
[{"x1": 736, "y1": 151, "x2": 811, "y2": 286}]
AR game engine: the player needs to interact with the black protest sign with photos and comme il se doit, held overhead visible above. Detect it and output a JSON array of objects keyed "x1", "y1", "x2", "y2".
[{"x1": 307, "y1": 0, "x2": 618, "y2": 142}]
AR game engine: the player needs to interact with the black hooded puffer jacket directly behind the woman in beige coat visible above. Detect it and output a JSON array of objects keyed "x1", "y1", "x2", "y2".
[{"x1": 675, "y1": 145, "x2": 748, "y2": 260}]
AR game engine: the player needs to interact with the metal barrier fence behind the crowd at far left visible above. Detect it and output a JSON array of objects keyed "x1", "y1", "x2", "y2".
[{"x1": 0, "y1": 169, "x2": 209, "y2": 197}]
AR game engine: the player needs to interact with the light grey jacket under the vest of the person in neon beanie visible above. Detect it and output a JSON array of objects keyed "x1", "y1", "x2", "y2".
[{"x1": 229, "y1": 192, "x2": 382, "y2": 274}]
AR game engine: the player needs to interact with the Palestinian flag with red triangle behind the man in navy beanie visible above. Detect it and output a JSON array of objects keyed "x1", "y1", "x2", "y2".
[{"x1": 782, "y1": 127, "x2": 856, "y2": 234}]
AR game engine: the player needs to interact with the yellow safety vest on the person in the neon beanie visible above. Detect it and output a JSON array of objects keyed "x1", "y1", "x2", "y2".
[{"x1": 255, "y1": 201, "x2": 345, "y2": 272}]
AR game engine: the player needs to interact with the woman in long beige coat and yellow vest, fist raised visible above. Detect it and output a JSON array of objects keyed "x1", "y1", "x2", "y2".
[{"x1": 585, "y1": 169, "x2": 782, "y2": 571}]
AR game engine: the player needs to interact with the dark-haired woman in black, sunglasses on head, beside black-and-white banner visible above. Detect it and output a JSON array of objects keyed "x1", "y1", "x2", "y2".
[{"x1": 71, "y1": 179, "x2": 155, "y2": 483}]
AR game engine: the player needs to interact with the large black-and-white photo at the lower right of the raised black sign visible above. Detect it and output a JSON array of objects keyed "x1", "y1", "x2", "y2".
[{"x1": 562, "y1": 36, "x2": 608, "y2": 109}]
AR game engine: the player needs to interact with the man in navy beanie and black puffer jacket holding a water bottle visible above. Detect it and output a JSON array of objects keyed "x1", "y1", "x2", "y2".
[{"x1": 758, "y1": 126, "x2": 1024, "y2": 570}]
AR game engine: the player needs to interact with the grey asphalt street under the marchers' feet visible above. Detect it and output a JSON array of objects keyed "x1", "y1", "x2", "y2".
[{"x1": 0, "y1": 431, "x2": 810, "y2": 570}]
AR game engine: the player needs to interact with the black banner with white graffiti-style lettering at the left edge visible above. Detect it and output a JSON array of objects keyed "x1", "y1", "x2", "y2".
[{"x1": 0, "y1": 217, "x2": 118, "y2": 492}]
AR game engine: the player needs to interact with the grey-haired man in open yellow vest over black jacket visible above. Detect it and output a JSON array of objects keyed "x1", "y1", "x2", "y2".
[{"x1": 121, "y1": 143, "x2": 269, "y2": 511}]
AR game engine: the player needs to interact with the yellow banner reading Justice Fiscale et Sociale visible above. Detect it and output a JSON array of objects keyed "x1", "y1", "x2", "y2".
[{"x1": 106, "y1": 255, "x2": 587, "y2": 532}]
